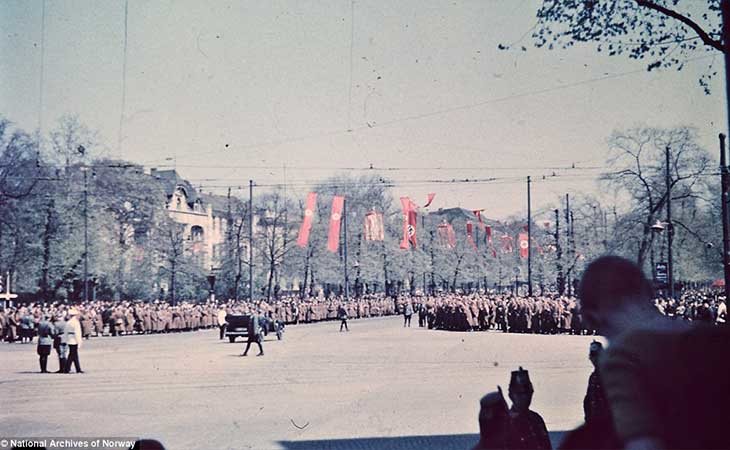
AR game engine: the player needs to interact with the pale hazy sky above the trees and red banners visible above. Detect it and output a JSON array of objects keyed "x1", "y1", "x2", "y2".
[{"x1": 0, "y1": 0, "x2": 727, "y2": 219}]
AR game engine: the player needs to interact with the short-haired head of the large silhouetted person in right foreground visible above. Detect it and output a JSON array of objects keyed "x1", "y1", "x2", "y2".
[{"x1": 578, "y1": 256, "x2": 660, "y2": 338}]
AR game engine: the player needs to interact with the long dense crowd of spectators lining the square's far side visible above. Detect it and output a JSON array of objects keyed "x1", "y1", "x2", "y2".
[{"x1": 0, "y1": 291, "x2": 727, "y2": 343}]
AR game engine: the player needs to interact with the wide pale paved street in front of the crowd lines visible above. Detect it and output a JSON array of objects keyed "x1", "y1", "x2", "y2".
[{"x1": 0, "y1": 317, "x2": 591, "y2": 450}]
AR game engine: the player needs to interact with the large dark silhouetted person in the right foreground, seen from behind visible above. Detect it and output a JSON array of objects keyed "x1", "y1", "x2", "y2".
[{"x1": 579, "y1": 256, "x2": 730, "y2": 449}]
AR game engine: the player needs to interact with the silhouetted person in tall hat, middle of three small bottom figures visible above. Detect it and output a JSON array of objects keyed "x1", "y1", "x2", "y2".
[{"x1": 507, "y1": 367, "x2": 552, "y2": 450}]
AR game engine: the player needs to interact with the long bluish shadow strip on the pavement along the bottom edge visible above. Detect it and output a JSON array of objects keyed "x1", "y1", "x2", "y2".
[{"x1": 279, "y1": 431, "x2": 566, "y2": 450}]
